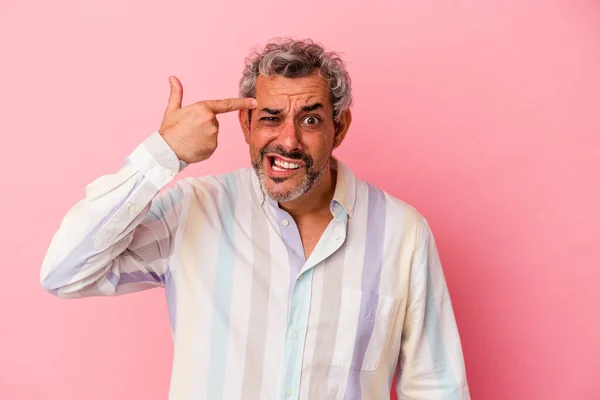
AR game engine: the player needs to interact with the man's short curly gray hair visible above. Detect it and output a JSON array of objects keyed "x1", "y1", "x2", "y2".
[{"x1": 239, "y1": 38, "x2": 352, "y2": 122}]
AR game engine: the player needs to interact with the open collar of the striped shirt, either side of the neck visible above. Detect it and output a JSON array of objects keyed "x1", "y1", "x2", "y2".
[{"x1": 251, "y1": 156, "x2": 357, "y2": 218}]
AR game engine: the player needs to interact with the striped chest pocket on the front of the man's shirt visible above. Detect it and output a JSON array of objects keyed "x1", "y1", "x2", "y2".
[{"x1": 332, "y1": 289, "x2": 400, "y2": 371}]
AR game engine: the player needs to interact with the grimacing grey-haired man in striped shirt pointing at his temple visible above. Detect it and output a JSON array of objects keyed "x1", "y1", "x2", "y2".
[{"x1": 41, "y1": 40, "x2": 469, "y2": 400}]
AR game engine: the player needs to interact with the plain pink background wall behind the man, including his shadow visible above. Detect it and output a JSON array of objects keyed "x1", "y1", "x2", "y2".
[{"x1": 0, "y1": 0, "x2": 600, "y2": 400}]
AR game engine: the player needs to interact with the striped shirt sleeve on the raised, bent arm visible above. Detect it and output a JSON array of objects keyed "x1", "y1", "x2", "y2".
[{"x1": 40, "y1": 132, "x2": 186, "y2": 298}]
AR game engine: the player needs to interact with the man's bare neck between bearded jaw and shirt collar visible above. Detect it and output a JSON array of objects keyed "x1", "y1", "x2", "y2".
[{"x1": 279, "y1": 161, "x2": 337, "y2": 218}]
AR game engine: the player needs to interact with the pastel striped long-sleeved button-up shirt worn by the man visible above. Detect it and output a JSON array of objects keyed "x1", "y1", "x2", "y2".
[{"x1": 41, "y1": 132, "x2": 470, "y2": 400}]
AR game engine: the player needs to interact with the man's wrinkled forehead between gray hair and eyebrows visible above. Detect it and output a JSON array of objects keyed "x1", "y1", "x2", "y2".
[{"x1": 255, "y1": 72, "x2": 331, "y2": 107}]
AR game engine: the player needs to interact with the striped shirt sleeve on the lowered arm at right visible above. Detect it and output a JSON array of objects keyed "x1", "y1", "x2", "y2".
[{"x1": 396, "y1": 220, "x2": 470, "y2": 400}]
